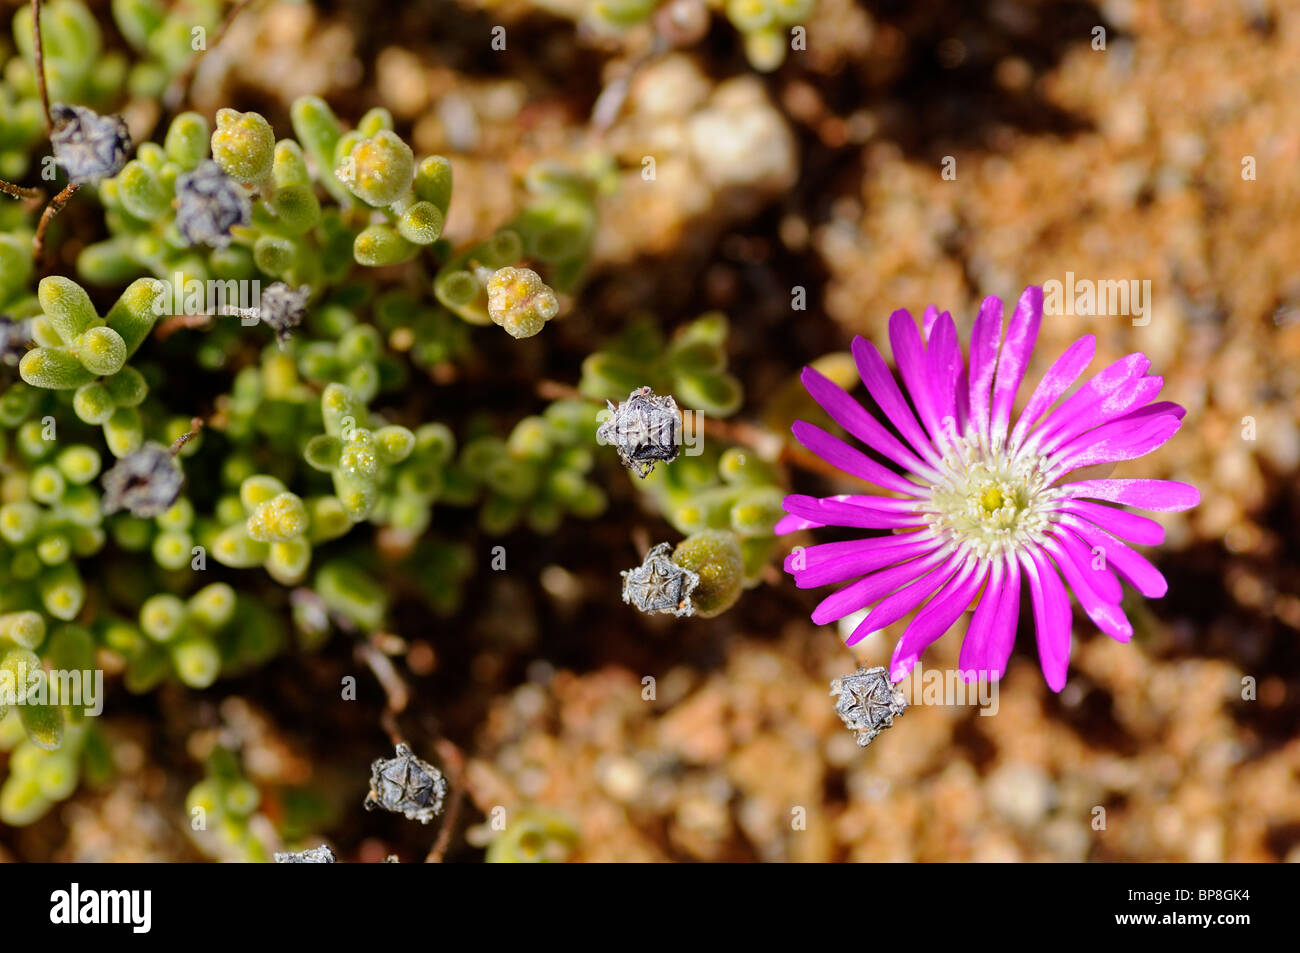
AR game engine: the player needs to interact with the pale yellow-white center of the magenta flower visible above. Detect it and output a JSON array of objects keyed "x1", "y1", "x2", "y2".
[{"x1": 927, "y1": 439, "x2": 1056, "y2": 556}]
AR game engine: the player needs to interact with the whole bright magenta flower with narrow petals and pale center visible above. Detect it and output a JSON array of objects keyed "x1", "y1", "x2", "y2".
[{"x1": 776, "y1": 287, "x2": 1200, "y2": 692}]
